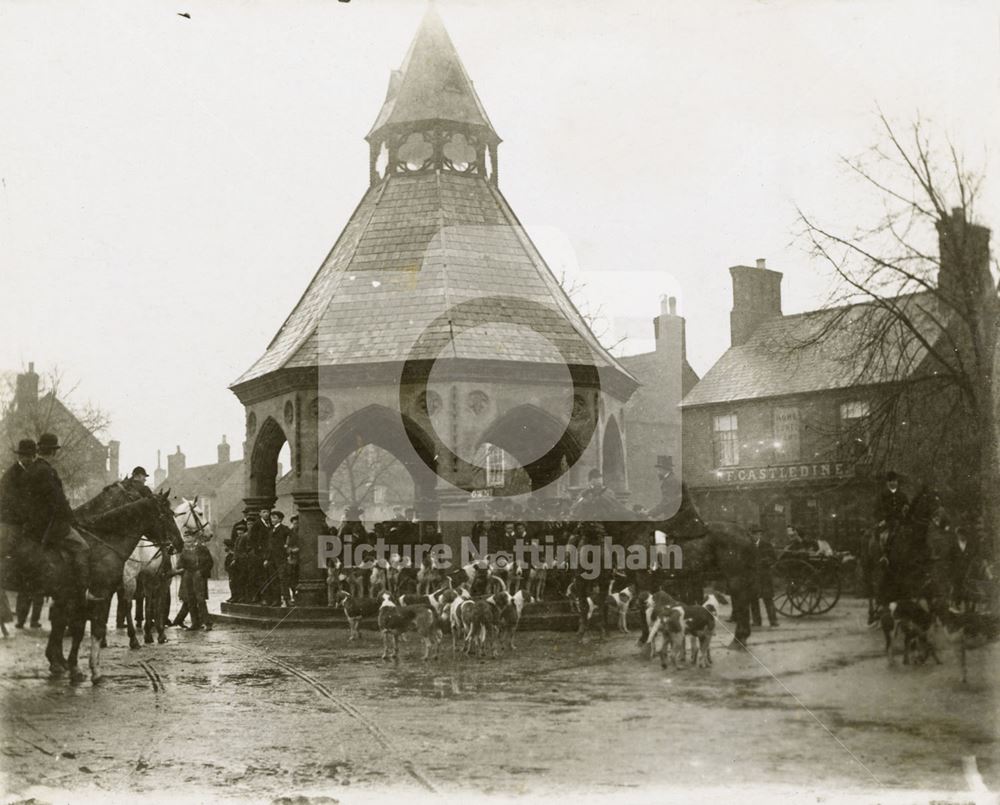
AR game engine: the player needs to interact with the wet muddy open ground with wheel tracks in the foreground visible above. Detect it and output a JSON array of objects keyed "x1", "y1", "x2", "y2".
[{"x1": 0, "y1": 600, "x2": 1000, "y2": 802}]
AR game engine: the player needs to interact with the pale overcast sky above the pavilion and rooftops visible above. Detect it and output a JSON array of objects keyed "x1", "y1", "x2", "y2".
[{"x1": 0, "y1": 0, "x2": 1000, "y2": 470}]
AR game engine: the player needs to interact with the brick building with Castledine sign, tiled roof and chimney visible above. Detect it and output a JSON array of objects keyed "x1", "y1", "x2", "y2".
[{"x1": 682, "y1": 229, "x2": 988, "y2": 548}]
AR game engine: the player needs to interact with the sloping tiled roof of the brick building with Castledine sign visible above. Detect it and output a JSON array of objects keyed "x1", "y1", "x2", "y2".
[{"x1": 681, "y1": 293, "x2": 939, "y2": 408}]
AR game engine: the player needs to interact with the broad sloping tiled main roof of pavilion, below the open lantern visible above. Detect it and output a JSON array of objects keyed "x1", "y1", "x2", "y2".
[{"x1": 234, "y1": 172, "x2": 630, "y2": 385}]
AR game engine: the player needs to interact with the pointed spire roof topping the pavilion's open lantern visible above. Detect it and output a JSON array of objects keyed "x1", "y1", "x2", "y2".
[{"x1": 366, "y1": 6, "x2": 500, "y2": 143}]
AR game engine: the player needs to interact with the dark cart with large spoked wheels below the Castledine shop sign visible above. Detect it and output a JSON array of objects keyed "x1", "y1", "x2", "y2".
[{"x1": 771, "y1": 551, "x2": 849, "y2": 618}]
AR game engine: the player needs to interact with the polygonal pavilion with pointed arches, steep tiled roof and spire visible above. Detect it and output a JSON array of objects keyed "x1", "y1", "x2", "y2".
[{"x1": 231, "y1": 7, "x2": 638, "y2": 602}]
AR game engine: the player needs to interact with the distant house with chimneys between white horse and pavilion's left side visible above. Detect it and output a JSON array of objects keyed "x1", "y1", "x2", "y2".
[{"x1": 156, "y1": 436, "x2": 243, "y2": 578}]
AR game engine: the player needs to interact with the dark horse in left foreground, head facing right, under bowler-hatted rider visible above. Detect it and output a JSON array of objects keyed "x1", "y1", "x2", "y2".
[{"x1": 40, "y1": 485, "x2": 182, "y2": 685}]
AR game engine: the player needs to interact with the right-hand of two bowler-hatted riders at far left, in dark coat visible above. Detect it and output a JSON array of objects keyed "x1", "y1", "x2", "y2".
[{"x1": 25, "y1": 433, "x2": 103, "y2": 601}]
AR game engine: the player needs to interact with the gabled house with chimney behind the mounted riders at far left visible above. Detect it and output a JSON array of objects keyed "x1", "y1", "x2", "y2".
[{"x1": 0, "y1": 363, "x2": 120, "y2": 506}]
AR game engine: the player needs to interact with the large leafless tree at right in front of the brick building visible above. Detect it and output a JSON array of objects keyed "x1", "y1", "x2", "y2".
[{"x1": 794, "y1": 114, "x2": 1000, "y2": 539}]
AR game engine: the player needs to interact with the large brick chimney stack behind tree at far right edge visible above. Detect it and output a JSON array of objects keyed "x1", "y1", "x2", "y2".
[{"x1": 937, "y1": 207, "x2": 996, "y2": 305}]
